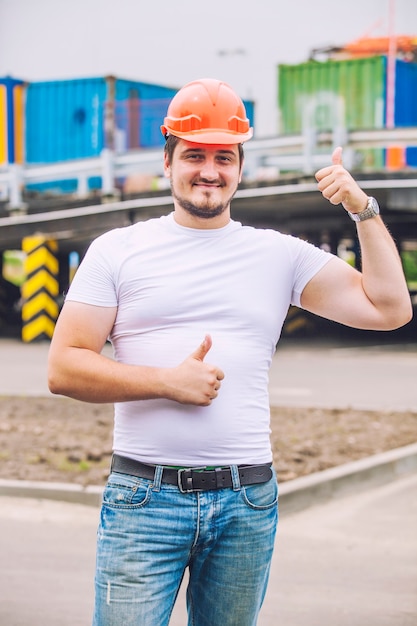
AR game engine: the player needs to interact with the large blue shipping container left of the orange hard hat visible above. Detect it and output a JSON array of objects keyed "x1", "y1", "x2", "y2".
[{"x1": 26, "y1": 77, "x2": 180, "y2": 163}]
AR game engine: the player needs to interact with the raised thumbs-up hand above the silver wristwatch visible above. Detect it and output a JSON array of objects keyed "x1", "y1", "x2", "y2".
[{"x1": 316, "y1": 147, "x2": 368, "y2": 213}]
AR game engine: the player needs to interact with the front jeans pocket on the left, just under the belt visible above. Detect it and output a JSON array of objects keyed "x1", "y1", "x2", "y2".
[{"x1": 103, "y1": 473, "x2": 152, "y2": 509}]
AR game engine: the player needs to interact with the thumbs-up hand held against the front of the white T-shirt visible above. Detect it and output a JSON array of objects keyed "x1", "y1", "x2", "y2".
[{"x1": 165, "y1": 335, "x2": 224, "y2": 406}]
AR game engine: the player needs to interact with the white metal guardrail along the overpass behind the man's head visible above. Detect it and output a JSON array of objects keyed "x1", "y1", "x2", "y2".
[{"x1": 0, "y1": 127, "x2": 417, "y2": 212}]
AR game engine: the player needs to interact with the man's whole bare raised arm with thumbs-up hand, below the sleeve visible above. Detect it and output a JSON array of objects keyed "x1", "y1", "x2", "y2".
[{"x1": 301, "y1": 148, "x2": 412, "y2": 330}]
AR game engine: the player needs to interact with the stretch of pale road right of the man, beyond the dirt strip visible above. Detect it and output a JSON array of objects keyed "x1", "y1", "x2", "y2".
[{"x1": 270, "y1": 333, "x2": 417, "y2": 411}]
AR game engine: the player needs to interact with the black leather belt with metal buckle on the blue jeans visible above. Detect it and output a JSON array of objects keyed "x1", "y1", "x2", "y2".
[{"x1": 111, "y1": 454, "x2": 272, "y2": 493}]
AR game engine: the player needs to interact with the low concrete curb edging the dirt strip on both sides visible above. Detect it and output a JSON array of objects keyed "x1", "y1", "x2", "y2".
[{"x1": 0, "y1": 443, "x2": 417, "y2": 515}]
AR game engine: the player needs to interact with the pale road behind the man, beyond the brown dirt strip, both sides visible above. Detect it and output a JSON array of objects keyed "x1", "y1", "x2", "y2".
[{"x1": 0, "y1": 333, "x2": 417, "y2": 410}]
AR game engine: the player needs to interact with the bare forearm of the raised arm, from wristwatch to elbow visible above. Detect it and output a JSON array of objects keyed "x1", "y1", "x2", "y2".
[{"x1": 357, "y1": 216, "x2": 412, "y2": 329}]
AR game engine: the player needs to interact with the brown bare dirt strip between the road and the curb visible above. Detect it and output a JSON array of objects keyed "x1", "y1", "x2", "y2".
[{"x1": 0, "y1": 396, "x2": 417, "y2": 485}]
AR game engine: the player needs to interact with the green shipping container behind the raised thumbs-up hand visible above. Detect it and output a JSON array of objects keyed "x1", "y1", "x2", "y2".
[{"x1": 278, "y1": 56, "x2": 386, "y2": 168}]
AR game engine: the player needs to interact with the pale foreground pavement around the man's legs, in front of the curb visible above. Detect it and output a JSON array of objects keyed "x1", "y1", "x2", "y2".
[{"x1": 0, "y1": 475, "x2": 417, "y2": 626}]
